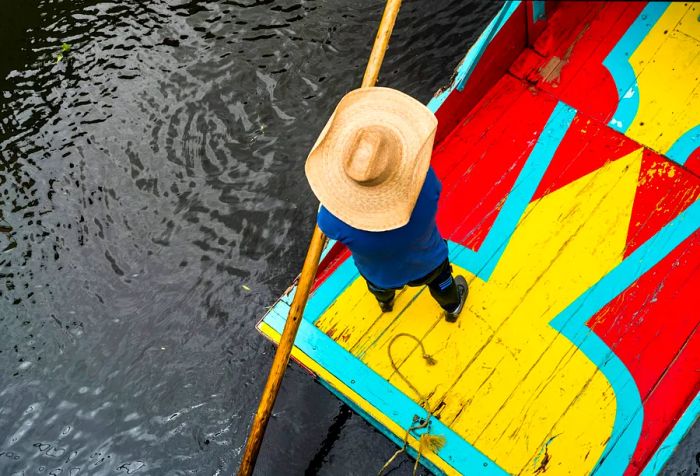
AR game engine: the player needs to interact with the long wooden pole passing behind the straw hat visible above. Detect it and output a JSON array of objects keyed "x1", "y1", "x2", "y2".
[{"x1": 238, "y1": 0, "x2": 401, "y2": 476}]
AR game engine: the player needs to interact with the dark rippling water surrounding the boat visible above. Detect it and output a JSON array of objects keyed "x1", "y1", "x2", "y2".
[{"x1": 0, "y1": 0, "x2": 697, "y2": 476}]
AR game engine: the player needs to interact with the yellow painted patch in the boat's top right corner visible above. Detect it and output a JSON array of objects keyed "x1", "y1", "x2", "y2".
[{"x1": 626, "y1": 2, "x2": 700, "y2": 153}]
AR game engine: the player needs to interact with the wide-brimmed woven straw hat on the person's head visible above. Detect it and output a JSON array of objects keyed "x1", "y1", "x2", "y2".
[{"x1": 306, "y1": 88, "x2": 437, "y2": 231}]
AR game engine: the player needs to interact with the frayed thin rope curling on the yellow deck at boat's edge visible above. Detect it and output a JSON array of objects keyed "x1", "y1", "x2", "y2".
[{"x1": 378, "y1": 332, "x2": 445, "y2": 476}]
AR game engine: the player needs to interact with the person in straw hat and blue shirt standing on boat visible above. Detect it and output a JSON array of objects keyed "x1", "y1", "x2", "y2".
[{"x1": 305, "y1": 87, "x2": 469, "y2": 322}]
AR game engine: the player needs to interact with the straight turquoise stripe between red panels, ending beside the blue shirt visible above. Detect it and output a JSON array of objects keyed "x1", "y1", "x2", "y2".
[{"x1": 450, "y1": 102, "x2": 576, "y2": 281}]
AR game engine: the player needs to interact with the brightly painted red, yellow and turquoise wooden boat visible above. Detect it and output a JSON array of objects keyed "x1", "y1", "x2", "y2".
[{"x1": 257, "y1": 1, "x2": 700, "y2": 476}]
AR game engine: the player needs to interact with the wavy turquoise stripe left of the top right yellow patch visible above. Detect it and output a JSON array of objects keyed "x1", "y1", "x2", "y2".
[{"x1": 603, "y1": 2, "x2": 670, "y2": 133}]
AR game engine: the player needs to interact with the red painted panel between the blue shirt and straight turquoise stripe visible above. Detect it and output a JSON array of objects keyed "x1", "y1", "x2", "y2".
[{"x1": 433, "y1": 75, "x2": 556, "y2": 250}]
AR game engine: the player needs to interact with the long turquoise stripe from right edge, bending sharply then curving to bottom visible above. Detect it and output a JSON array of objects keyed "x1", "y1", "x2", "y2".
[{"x1": 551, "y1": 202, "x2": 700, "y2": 475}]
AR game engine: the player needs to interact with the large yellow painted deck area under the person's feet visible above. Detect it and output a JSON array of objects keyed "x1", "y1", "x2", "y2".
[{"x1": 312, "y1": 149, "x2": 642, "y2": 474}]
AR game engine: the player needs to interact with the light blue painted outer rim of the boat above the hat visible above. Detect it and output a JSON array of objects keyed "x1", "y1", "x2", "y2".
[{"x1": 428, "y1": 0, "x2": 521, "y2": 112}]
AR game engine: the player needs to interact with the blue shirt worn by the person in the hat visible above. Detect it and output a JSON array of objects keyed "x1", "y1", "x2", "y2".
[{"x1": 318, "y1": 167, "x2": 447, "y2": 289}]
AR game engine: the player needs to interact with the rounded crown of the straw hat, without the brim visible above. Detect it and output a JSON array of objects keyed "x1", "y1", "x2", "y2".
[{"x1": 343, "y1": 126, "x2": 401, "y2": 186}]
